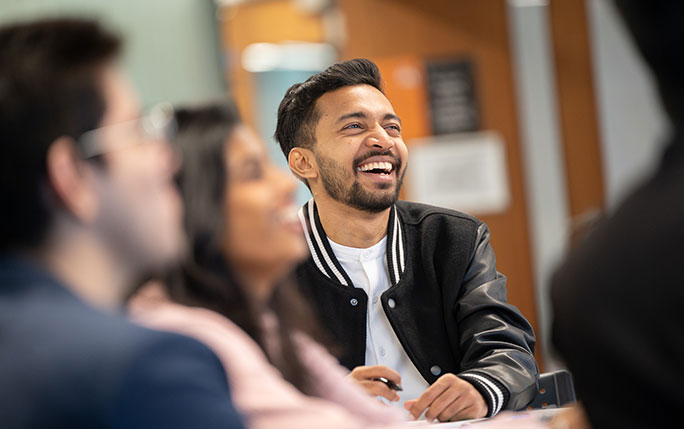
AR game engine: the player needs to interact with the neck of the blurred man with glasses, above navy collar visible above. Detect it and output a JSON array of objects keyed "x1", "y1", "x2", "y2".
[{"x1": 31, "y1": 222, "x2": 131, "y2": 310}]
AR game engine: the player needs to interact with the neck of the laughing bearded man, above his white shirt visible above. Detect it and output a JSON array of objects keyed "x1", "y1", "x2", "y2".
[{"x1": 316, "y1": 196, "x2": 391, "y2": 249}]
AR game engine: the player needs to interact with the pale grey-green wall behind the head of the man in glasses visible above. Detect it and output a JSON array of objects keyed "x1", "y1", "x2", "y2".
[{"x1": 0, "y1": 0, "x2": 226, "y2": 105}]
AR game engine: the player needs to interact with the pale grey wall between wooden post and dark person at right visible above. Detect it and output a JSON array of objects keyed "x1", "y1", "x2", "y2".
[{"x1": 586, "y1": 0, "x2": 668, "y2": 209}]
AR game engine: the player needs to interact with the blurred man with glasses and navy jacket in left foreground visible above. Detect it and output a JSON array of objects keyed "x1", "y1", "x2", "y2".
[{"x1": 0, "y1": 19, "x2": 242, "y2": 428}]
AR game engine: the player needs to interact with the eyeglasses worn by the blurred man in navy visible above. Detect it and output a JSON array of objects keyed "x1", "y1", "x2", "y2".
[{"x1": 77, "y1": 103, "x2": 176, "y2": 159}]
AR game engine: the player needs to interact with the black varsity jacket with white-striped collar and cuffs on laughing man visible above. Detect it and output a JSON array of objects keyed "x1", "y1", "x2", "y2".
[{"x1": 297, "y1": 200, "x2": 539, "y2": 416}]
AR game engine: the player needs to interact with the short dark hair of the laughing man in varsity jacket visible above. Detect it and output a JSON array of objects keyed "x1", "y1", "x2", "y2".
[{"x1": 275, "y1": 58, "x2": 382, "y2": 158}]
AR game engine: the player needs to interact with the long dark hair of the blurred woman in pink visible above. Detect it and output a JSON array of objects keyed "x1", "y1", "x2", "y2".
[{"x1": 165, "y1": 102, "x2": 312, "y2": 393}]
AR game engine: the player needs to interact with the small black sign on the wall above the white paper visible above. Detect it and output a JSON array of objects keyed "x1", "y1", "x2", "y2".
[{"x1": 427, "y1": 59, "x2": 480, "y2": 135}]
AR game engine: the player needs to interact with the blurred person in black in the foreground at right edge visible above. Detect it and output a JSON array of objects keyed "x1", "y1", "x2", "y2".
[{"x1": 552, "y1": 0, "x2": 684, "y2": 428}]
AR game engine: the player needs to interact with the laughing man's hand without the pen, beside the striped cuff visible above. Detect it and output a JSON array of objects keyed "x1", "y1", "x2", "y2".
[{"x1": 404, "y1": 374, "x2": 487, "y2": 422}]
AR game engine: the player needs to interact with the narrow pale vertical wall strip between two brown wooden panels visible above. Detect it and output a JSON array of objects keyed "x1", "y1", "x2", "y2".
[{"x1": 508, "y1": 0, "x2": 569, "y2": 370}]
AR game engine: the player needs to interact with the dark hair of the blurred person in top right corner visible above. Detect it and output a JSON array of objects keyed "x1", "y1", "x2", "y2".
[{"x1": 615, "y1": 0, "x2": 684, "y2": 123}]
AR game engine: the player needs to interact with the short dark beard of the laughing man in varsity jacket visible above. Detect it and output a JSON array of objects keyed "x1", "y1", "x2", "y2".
[{"x1": 316, "y1": 153, "x2": 406, "y2": 213}]
